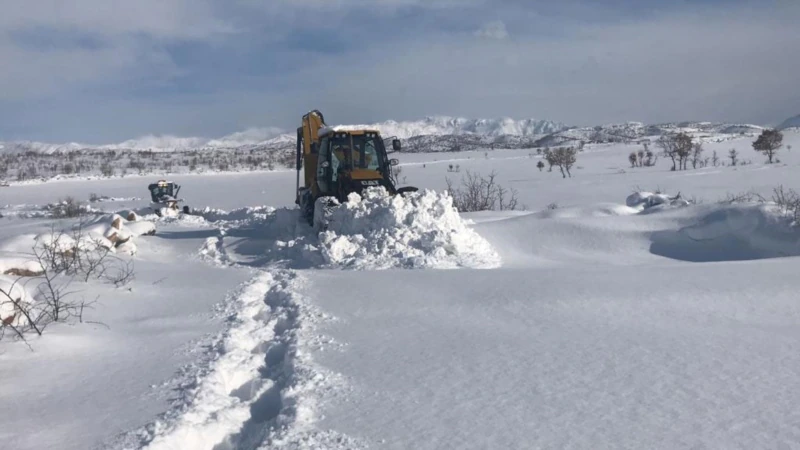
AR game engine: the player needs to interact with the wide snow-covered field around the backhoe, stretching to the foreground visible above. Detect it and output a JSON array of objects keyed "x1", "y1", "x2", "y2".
[{"x1": 0, "y1": 130, "x2": 800, "y2": 450}]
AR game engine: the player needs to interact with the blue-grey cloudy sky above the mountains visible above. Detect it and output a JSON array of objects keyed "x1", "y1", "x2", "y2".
[{"x1": 0, "y1": 0, "x2": 800, "y2": 144}]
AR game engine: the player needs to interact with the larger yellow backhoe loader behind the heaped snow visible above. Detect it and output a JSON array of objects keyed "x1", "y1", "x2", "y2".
[{"x1": 295, "y1": 110, "x2": 417, "y2": 227}]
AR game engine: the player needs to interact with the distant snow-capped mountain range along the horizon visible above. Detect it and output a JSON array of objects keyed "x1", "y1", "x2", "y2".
[{"x1": 0, "y1": 116, "x2": 800, "y2": 153}]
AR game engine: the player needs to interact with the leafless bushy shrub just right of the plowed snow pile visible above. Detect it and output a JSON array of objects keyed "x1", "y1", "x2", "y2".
[{"x1": 446, "y1": 171, "x2": 519, "y2": 212}]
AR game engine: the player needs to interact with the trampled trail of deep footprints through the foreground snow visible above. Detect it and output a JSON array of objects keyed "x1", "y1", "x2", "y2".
[{"x1": 122, "y1": 270, "x2": 354, "y2": 450}]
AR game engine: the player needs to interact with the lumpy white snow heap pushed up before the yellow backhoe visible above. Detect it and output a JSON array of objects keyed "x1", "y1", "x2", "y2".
[{"x1": 319, "y1": 188, "x2": 500, "y2": 269}]
